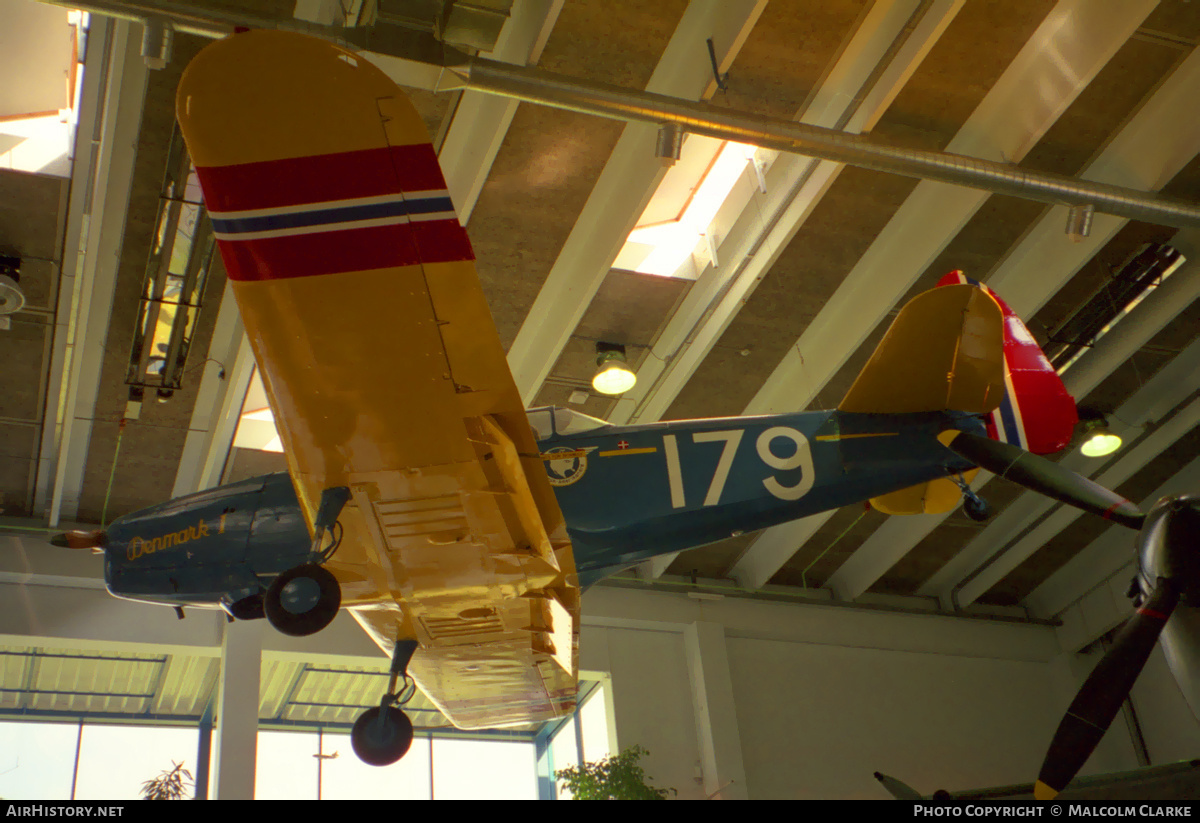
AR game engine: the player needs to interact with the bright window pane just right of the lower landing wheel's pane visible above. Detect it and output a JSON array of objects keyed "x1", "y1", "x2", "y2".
[{"x1": 433, "y1": 738, "x2": 538, "y2": 800}]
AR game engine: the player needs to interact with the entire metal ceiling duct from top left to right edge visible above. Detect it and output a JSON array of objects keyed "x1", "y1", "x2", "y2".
[{"x1": 47, "y1": 0, "x2": 1200, "y2": 228}]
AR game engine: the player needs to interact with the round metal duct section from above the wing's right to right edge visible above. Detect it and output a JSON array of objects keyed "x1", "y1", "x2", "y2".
[{"x1": 451, "y1": 58, "x2": 1200, "y2": 228}]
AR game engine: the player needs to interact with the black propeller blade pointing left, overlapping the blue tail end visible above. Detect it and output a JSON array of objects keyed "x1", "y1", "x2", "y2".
[{"x1": 942, "y1": 432, "x2": 1146, "y2": 529}]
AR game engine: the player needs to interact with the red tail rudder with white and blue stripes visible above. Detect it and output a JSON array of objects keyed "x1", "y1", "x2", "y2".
[{"x1": 937, "y1": 271, "x2": 1079, "y2": 455}]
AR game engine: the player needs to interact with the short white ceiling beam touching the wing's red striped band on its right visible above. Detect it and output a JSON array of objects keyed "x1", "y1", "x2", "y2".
[{"x1": 438, "y1": 0, "x2": 565, "y2": 226}]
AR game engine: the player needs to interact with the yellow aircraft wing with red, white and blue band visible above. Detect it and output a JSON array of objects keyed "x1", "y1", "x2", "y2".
[{"x1": 176, "y1": 31, "x2": 578, "y2": 728}]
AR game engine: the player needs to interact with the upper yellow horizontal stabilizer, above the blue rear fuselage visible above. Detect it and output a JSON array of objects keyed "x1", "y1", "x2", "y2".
[{"x1": 838, "y1": 286, "x2": 1004, "y2": 414}]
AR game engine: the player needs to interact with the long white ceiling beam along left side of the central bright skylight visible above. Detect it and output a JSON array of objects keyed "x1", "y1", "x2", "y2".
[{"x1": 509, "y1": 0, "x2": 766, "y2": 406}]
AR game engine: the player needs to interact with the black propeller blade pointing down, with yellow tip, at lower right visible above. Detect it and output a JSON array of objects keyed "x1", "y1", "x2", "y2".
[{"x1": 1033, "y1": 577, "x2": 1180, "y2": 800}]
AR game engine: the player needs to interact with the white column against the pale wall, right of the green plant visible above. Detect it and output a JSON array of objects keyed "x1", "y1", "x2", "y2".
[{"x1": 683, "y1": 620, "x2": 749, "y2": 800}]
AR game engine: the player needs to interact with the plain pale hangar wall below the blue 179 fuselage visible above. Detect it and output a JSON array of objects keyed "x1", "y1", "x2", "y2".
[{"x1": 581, "y1": 588, "x2": 1200, "y2": 799}]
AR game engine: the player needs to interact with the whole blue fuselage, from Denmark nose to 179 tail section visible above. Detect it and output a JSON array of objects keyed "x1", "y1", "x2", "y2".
[{"x1": 106, "y1": 410, "x2": 984, "y2": 606}]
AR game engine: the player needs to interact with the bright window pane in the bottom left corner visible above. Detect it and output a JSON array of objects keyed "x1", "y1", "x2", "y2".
[{"x1": 0, "y1": 722, "x2": 79, "y2": 800}]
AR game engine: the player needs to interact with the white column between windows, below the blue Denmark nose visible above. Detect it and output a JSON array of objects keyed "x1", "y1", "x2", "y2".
[{"x1": 209, "y1": 620, "x2": 265, "y2": 800}]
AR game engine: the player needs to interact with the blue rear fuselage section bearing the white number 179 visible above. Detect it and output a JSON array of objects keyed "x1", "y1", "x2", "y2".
[{"x1": 539, "y1": 412, "x2": 984, "y2": 584}]
